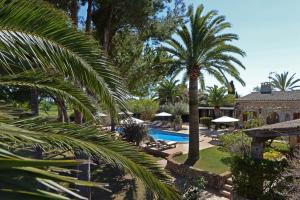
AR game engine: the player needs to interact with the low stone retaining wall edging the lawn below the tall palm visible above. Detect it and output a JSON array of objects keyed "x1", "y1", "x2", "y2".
[{"x1": 166, "y1": 152, "x2": 231, "y2": 190}]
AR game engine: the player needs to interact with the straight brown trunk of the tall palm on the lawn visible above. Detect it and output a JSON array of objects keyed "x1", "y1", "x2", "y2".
[{"x1": 185, "y1": 67, "x2": 199, "y2": 165}]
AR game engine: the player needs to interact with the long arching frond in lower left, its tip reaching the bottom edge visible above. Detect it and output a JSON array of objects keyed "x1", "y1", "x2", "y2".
[{"x1": 0, "y1": 118, "x2": 179, "y2": 199}]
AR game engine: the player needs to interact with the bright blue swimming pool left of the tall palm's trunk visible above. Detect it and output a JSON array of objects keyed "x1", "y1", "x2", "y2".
[{"x1": 149, "y1": 129, "x2": 189, "y2": 142}]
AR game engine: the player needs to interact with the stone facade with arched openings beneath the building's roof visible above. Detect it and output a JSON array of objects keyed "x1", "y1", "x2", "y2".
[{"x1": 236, "y1": 101, "x2": 300, "y2": 124}]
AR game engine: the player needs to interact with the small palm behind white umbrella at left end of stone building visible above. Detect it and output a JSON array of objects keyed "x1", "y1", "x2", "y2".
[{"x1": 207, "y1": 85, "x2": 235, "y2": 117}]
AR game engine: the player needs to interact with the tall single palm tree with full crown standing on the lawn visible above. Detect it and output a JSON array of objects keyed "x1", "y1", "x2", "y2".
[{"x1": 163, "y1": 5, "x2": 245, "y2": 164}]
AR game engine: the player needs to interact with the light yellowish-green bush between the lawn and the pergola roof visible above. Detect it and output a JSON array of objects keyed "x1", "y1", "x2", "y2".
[{"x1": 220, "y1": 131, "x2": 251, "y2": 156}]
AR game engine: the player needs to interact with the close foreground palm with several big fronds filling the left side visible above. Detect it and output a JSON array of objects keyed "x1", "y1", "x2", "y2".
[{"x1": 0, "y1": 0, "x2": 179, "y2": 199}]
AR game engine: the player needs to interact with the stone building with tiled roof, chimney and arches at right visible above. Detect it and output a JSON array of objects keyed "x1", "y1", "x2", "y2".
[{"x1": 236, "y1": 82, "x2": 300, "y2": 124}]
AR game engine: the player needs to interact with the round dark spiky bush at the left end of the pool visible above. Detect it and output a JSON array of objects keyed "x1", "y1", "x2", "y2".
[{"x1": 122, "y1": 121, "x2": 148, "y2": 146}]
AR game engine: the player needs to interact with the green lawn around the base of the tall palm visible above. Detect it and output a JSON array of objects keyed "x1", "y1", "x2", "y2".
[{"x1": 174, "y1": 147, "x2": 230, "y2": 174}]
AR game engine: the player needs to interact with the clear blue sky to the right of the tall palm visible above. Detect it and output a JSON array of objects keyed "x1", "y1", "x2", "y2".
[{"x1": 190, "y1": 0, "x2": 300, "y2": 95}]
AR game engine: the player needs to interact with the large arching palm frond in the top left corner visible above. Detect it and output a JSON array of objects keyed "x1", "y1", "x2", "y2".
[{"x1": 0, "y1": 0, "x2": 126, "y2": 115}]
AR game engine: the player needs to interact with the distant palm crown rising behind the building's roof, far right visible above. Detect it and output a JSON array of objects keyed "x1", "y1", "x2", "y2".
[{"x1": 269, "y1": 72, "x2": 300, "y2": 91}]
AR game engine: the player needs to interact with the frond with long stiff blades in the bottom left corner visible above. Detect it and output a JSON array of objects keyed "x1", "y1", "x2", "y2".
[{"x1": 0, "y1": 148, "x2": 107, "y2": 200}]
